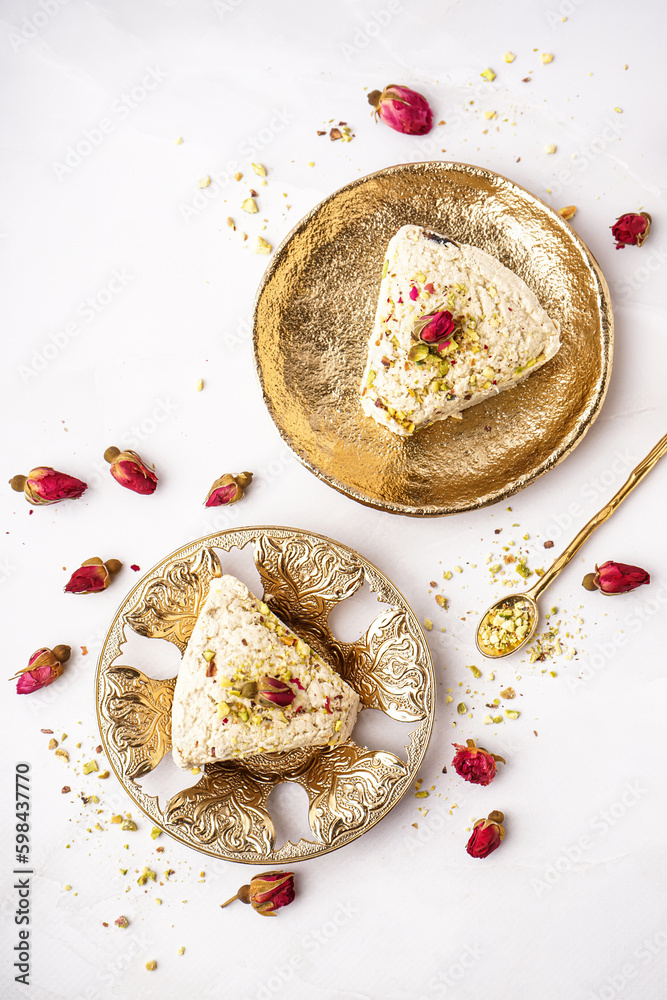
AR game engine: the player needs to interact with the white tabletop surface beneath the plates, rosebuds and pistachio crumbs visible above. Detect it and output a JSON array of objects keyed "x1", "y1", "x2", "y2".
[{"x1": 0, "y1": 0, "x2": 667, "y2": 1000}]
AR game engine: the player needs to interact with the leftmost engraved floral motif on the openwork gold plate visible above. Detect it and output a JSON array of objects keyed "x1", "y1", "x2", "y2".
[{"x1": 107, "y1": 666, "x2": 176, "y2": 781}]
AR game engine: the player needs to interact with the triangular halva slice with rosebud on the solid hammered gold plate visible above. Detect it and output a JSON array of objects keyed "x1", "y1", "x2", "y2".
[{"x1": 361, "y1": 226, "x2": 560, "y2": 436}]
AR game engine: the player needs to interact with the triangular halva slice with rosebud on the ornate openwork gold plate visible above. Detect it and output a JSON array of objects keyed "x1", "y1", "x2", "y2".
[{"x1": 171, "y1": 576, "x2": 359, "y2": 767}]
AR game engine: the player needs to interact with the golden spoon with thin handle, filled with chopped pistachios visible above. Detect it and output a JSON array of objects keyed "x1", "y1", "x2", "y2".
[{"x1": 475, "y1": 434, "x2": 667, "y2": 660}]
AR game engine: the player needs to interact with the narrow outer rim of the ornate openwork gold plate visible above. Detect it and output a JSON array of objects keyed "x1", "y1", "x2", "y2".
[{"x1": 95, "y1": 525, "x2": 437, "y2": 865}]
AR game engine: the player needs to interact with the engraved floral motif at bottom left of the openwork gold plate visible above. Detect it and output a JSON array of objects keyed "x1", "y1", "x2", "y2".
[{"x1": 165, "y1": 762, "x2": 276, "y2": 854}]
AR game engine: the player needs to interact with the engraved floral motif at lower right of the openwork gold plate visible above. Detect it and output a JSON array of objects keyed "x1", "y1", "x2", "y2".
[{"x1": 306, "y1": 740, "x2": 409, "y2": 845}]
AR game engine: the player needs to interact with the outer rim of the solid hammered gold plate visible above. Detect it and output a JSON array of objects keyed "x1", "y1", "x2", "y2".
[{"x1": 252, "y1": 160, "x2": 614, "y2": 517}]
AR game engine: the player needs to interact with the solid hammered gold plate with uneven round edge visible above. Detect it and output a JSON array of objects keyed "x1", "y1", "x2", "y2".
[{"x1": 254, "y1": 162, "x2": 613, "y2": 516}]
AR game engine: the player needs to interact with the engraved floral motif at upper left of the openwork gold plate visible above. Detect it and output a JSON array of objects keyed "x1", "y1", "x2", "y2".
[{"x1": 125, "y1": 548, "x2": 222, "y2": 653}]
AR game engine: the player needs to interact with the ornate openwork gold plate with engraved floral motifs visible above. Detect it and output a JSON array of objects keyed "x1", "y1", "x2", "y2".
[{"x1": 96, "y1": 527, "x2": 435, "y2": 864}]
